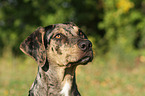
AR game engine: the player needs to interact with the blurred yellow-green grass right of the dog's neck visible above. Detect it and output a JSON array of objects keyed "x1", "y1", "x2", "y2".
[{"x1": 77, "y1": 55, "x2": 145, "y2": 96}]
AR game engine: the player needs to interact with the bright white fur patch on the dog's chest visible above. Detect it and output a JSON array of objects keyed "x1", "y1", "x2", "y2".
[{"x1": 60, "y1": 81, "x2": 71, "y2": 96}]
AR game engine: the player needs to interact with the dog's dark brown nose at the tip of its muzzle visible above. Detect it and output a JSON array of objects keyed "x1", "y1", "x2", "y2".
[{"x1": 78, "y1": 40, "x2": 92, "y2": 51}]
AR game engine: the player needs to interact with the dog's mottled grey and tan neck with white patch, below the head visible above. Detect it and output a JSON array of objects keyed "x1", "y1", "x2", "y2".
[{"x1": 30, "y1": 64, "x2": 80, "y2": 96}]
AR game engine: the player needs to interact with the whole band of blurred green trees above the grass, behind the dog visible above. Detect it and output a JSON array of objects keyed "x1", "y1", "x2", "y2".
[{"x1": 0, "y1": 0, "x2": 145, "y2": 54}]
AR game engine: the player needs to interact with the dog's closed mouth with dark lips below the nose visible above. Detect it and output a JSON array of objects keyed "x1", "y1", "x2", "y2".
[{"x1": 66, "y1": 56, "x2": 93, "y2": 67}]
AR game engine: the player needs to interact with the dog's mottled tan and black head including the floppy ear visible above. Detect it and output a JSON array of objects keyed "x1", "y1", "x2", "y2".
[{"x1": 20, "y1": 23, "x2": 93, "y2": 70}]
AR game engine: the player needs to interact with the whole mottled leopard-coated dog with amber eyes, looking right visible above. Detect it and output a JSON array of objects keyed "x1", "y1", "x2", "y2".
[{"x1": 20, "y1": 23, "x2": 93, "y2": 96}]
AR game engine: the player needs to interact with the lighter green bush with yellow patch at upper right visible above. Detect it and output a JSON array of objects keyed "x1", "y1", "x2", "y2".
[{"x1": 98, "y1": 0, "x2": 145, "y2": 49}]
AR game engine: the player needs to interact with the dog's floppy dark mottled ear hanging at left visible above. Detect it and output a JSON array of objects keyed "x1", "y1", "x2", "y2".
[{"x1": 20, "y1": 27, "x2": 46, "y2": 67}]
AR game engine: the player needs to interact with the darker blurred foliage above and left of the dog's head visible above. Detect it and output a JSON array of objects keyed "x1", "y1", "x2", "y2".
[{"x1": 0, "y1": 0, "x2": 103, "y2": 54}]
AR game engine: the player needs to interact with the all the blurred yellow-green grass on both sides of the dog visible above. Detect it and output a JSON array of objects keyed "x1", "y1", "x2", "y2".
[{"x1": 0, "y1": 48, "x2": 145, "y2": 96}]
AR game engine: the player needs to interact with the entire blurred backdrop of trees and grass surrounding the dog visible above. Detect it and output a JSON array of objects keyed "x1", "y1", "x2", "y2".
[{"x1": 0, "y1": 0, "x2": 145, "y2": 96}]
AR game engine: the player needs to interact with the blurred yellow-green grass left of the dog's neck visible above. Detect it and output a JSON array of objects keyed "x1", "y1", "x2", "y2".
[{"x1": 0, "y1": 48, "x2": 37, "y2": 96}]
